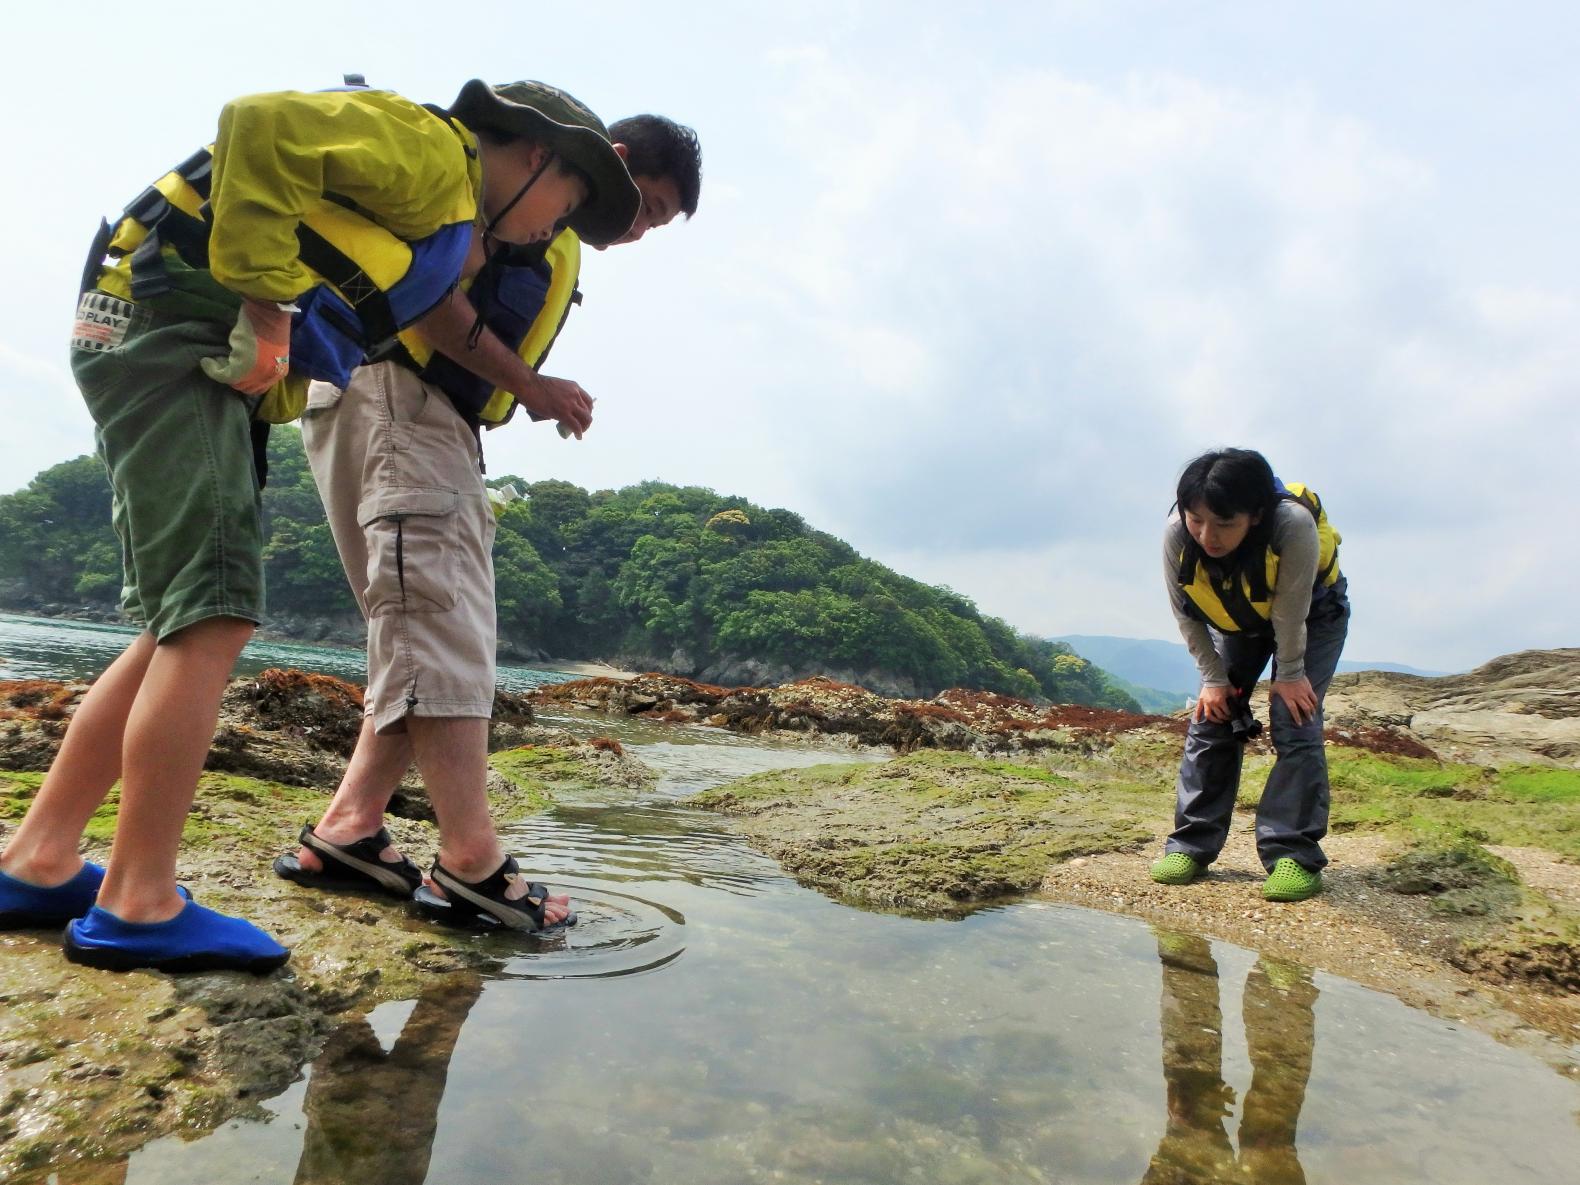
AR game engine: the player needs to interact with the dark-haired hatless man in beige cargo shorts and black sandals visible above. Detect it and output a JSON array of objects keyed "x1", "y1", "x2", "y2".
[{"x1": 275, "y1": 109, "x2": 702, "y2": 929}]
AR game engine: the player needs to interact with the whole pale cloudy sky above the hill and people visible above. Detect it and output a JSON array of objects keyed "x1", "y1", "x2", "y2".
[{"x1": 0, "y1": 0, "x2": 1580, "y2": 668}]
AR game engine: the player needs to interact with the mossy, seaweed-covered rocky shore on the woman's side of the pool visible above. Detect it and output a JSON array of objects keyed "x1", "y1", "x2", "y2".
[{"x1": 546, "y1": 663, "x2": 1580, "y2": 1073}]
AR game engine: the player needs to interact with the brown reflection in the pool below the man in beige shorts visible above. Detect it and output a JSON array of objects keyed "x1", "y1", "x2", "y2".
[{"x1": 295, "y1": 975, "x2": 483, "y2": 1185}]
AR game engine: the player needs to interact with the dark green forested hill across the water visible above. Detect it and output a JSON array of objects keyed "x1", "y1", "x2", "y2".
[{"x1": 0, "y1": 428, "x2": 1136, "y2": 709}]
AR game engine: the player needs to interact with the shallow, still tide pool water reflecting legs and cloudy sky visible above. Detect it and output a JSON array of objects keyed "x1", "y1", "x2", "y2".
[{"x1": 12, "y1": 616, "x2": 1580, "y2": 1185}]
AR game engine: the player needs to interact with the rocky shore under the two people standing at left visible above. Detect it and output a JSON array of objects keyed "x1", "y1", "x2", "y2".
[{"x1": 0, "y1": 670, "x2": 653, "y2": 1180}]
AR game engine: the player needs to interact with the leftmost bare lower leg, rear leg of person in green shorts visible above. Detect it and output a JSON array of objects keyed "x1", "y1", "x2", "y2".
[{"x1": 0, "y1": 634, "x2": 155, "y2": 885}]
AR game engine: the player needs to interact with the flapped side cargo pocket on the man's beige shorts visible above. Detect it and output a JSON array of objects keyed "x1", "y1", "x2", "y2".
[{"x1": 357, "y1": 488, "x2": 461, "y2": 618}]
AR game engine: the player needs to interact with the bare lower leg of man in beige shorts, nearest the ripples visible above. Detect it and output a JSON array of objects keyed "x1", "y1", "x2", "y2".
[{"x1": 406, "y1": 716, "x2": 570, "y2": 926}]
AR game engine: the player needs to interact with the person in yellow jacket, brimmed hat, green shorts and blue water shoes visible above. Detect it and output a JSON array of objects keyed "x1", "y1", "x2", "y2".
[{"x1": 0, "y1": 84, "x2": 638, "y2": 973}]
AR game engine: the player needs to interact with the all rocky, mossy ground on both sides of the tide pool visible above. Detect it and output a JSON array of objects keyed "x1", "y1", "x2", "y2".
[{"x1": 0, "y1": 651, "x2": 1580, "y2": 1180}]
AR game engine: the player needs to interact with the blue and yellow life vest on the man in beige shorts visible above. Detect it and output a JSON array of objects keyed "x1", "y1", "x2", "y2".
[{"x1": 398, "y1": 229, "x2": 581, "y2": 427}]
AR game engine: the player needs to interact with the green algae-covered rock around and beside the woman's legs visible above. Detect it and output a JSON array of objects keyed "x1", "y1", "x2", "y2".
[{"x1": 689, "y1": 742, "x2": 1580, "y2": 1011}]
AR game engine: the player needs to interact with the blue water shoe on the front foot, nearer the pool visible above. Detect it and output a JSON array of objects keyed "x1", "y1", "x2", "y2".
[{"x1": 63, "y1": 901, "x2": 291, "y2": 975}]
